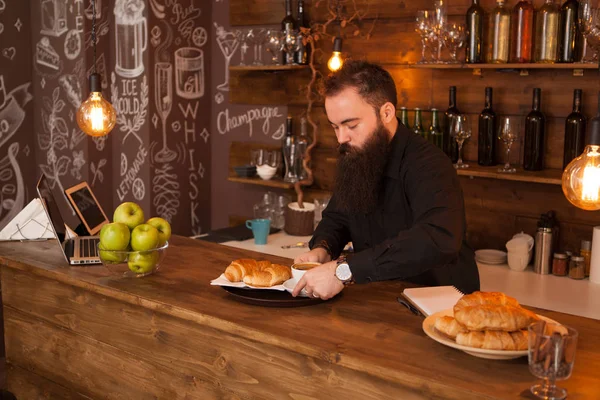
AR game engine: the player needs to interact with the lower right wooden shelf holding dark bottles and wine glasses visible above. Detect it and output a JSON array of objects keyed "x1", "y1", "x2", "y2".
[{"x1": 456, "y1": 161, "x2": 563, "y2": 185}]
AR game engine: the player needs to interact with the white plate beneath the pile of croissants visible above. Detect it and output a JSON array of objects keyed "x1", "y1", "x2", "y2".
[{"x1": 423, "y1": 309, "x2": 558, "y2": 360}]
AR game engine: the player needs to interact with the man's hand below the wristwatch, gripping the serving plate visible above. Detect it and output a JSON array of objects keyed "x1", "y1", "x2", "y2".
[{"x1": 292, "y1": 261, "x2": 344, "y2": 300}]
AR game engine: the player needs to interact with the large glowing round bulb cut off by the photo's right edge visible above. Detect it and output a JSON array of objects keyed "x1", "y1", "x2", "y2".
[{"x1": 562, "y1": 145, "x2": 600, "y2": 211}]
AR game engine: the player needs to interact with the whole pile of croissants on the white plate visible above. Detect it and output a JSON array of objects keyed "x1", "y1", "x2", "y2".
[{"x1": 435, "y1": 292, "x2": 539, "y2": 350}]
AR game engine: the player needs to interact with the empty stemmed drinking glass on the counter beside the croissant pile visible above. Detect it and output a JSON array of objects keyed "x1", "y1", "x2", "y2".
[{"x1": 528, "y1": 320, "x2": 578, "y2": 400}]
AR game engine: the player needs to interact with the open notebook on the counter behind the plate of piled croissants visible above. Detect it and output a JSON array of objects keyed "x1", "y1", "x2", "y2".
[{"x1": 402, "y1": 286, "x2": 463, "y2": 317}]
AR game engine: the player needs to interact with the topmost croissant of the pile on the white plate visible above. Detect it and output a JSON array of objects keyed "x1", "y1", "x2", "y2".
[{"x1": 454, "y1": 305, "x2": 539, "y2": 332}]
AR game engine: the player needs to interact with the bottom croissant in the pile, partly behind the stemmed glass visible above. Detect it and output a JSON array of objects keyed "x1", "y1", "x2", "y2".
[{"x1": 456, "y1": 330, "x2": 528, "y2": 350}]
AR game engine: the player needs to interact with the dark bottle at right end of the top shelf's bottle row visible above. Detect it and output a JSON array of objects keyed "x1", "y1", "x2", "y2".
[{"x1": 558, "y1": 0, "x2": 583, "y2": 63}]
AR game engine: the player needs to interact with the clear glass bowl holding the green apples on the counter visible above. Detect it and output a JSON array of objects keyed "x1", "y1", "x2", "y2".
[{"x1": 98, "y1": 242, "x2": 169, "y2": 278}]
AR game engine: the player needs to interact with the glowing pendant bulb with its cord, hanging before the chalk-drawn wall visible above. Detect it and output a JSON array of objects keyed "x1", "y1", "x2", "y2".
[{"x1": 76, "y1": 0, "x2": 117, "y2": 136}]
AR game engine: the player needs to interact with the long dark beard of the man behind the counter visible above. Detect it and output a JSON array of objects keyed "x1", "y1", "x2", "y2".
[{"x1": 335, "y1": 121, "x2": 390, "y2": 214}]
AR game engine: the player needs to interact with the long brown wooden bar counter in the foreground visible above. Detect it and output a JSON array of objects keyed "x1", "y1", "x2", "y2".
[{"x1": 0, "y1": 237, "x2": 600, "y2": 400}]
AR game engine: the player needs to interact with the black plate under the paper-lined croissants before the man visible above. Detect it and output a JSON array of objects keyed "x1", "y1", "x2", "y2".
[{"x1": 221, "y1": 286, "x2": 324, "y2": 307}]
